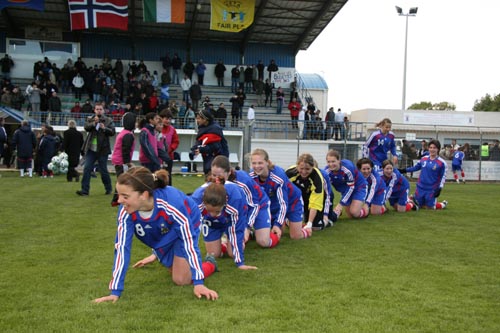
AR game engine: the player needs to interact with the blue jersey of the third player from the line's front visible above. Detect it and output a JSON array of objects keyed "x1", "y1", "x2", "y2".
[{"x1": 234, "y1": 170, "x2": 270, "y2": 229}]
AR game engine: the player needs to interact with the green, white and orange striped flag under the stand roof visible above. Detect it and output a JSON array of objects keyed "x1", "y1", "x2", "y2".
[{"x1": 144, "y1": 0, "x2": 186, "y2": 23}]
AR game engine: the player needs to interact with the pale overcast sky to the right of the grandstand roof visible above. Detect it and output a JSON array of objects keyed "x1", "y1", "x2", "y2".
[{"x1": 296, "y1": 0, "x2": 500, "y2": 113}]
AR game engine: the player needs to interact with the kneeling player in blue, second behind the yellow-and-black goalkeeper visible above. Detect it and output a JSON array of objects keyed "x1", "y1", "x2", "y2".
[{"x1": 356, "y1": 158, "x2": 387, "y2": 215}]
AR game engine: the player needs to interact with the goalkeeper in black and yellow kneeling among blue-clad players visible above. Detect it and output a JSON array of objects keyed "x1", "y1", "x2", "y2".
[{"x1": 286, "y1": 153, "x2": 337, "y2": 230}]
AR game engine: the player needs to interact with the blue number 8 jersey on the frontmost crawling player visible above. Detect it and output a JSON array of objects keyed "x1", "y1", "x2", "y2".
[{"x1": 109, "y1": 186, "x2": 204, "y2": 296}]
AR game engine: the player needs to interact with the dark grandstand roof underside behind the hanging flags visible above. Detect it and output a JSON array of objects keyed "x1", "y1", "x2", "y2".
[{"x1": 0, "y1": 0, "x2": 348, "y2": 54}]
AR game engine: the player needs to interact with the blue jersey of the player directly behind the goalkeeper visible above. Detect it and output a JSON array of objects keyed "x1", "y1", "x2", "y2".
[{"x1": 325, "y1": 160, "x2": 368, "y2": 206}]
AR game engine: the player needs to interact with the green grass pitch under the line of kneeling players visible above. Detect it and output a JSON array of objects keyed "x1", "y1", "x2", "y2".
[{"x1": 0, "y1": 172, "x2": 500, "y2": 332}]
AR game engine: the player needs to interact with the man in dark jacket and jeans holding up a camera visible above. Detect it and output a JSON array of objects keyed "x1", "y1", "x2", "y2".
[{"x1": 76, "y1": 102, "x2": 115, "y2": 196}]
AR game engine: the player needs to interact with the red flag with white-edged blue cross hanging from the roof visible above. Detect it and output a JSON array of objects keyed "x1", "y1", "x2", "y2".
[{"x1": 68, "y1": 0, "x2": 128, "y2": 30}]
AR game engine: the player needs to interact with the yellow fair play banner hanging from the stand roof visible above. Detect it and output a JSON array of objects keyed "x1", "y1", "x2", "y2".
[{"x1": 210, "y1": 0, "x2": 255, "y2": 32}]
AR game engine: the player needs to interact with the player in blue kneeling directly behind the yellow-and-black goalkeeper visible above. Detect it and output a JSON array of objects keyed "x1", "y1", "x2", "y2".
[{"x1": 325, "y1": 150, "x2": 369, "y2": 218}]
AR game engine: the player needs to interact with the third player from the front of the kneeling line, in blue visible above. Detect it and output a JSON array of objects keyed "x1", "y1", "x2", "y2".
[{"x1": 212, "y1": 155, "x2": 279, "y2": 248}]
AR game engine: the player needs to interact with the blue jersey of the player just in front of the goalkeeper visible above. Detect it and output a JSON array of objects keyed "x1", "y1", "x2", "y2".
[{"x1": 249, "y1": 165, "x2": 304, "y2": 227}]
